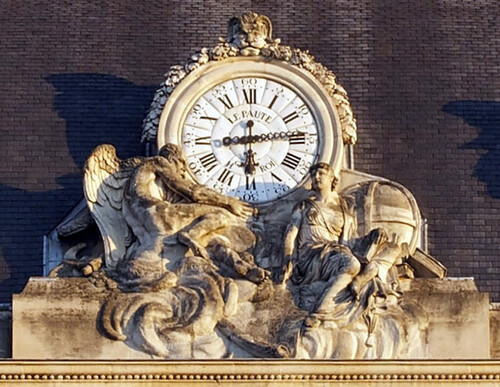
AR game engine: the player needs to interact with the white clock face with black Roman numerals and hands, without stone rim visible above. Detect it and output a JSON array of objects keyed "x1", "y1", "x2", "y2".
[{"x1": 180, "y1": 77, "x2": 319, "y2": 203}]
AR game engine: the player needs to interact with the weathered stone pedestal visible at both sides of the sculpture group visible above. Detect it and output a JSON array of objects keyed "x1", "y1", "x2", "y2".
[{"x1": 13, "y1": 278, "x2": 490, "y2": 360}]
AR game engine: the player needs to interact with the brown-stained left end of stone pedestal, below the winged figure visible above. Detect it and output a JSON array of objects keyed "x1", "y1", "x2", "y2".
[{"x1": 12, "y1": 277, "x2": 151, "y2": 359}]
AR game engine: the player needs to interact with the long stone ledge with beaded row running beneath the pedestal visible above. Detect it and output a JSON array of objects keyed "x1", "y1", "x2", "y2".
[{"x1": 0, "y1": 361, "x2": 500, "y2": 386}]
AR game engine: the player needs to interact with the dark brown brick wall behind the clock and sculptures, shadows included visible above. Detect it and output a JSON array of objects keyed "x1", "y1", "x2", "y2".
[{"x1": 0, "y1": 0, "x2": 500, "y2": 302}]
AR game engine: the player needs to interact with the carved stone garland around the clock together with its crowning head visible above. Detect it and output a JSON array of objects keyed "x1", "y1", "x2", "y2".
[{"x1": 142, "y1": 12, "x2": 357, "y2": 145}]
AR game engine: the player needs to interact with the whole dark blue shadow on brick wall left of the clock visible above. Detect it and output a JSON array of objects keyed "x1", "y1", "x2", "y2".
[{"x1": 0, "y1": 74, "x2": 156, "y2": 302}]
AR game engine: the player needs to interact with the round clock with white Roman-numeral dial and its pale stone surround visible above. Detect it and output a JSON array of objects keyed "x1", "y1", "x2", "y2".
[{"x1": 157, "y1": 57, "x2": 343, "y2": 204}]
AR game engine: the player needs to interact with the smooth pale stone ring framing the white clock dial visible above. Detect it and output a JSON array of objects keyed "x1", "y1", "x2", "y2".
[{"x1": 157, "y1": 57, "x2": 344, "y2": 189}]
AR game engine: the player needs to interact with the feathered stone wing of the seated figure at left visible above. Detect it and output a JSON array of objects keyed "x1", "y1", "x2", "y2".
[{"x1": 83, "y1": 144, "x2": 140, "y2": 268}]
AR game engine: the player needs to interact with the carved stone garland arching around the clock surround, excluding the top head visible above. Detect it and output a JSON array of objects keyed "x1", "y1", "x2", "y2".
[{"x1": 141, "y1": 38, "x2": 357, "y2": 145}]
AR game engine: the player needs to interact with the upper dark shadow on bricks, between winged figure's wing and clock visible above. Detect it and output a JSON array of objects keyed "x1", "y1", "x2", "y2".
[{"x1": 45, "y1": 74, "x2": 156, "y2": 168}]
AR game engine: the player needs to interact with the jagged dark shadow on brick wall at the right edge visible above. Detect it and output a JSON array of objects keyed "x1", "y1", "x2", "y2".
[{"x1": 443, "y1": 101, "x2": 500, "y2": 199}]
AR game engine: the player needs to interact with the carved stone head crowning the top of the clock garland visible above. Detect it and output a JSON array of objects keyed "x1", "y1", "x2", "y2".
[{"x1": 226, "y1": 12, "x2": 273, "y2": 55}]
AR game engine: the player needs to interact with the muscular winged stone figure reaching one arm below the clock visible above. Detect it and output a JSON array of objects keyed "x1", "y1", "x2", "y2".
[{"x1": 84, "y1": 144, "x2": 252, "y2": 269}]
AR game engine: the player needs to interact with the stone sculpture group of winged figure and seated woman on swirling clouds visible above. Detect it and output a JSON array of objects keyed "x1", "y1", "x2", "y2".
[{"x1": 63, "y1": 144, "x2": 425, "y2": 359}]
